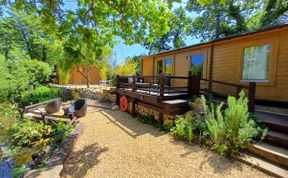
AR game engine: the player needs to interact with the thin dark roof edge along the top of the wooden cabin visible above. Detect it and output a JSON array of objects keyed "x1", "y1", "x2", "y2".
[{"x1": 142, "y1": 24, "x2": 288, "y2": 59}]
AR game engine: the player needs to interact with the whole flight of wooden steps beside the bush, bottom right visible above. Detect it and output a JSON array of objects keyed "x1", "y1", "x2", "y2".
[{"x1": 237, "y1": 111, "x2": 288, "y2": 178}]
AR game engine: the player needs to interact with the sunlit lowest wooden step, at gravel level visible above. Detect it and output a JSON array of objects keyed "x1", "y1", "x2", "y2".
[{"x1": 234, "y1": 153, "x2": 288, "y2": 178}]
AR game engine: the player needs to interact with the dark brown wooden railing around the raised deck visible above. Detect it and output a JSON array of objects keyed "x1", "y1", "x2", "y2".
[{"x1": 116, "y1": 72, "x2": 256, "y2": 112}]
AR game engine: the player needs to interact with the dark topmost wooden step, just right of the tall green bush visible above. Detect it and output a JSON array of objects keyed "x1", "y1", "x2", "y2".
[{"x1": 255, "y1": 111, "x2": 288, "y2": 134}]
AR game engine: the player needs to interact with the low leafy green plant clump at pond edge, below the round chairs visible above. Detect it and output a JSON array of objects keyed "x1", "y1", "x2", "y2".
[{"x1": 8, "y1": 118, "x2": 52, "y2": 147}]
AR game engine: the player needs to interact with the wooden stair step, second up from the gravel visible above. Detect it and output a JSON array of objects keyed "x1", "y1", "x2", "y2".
[{"x1": 248, "y1": 142, "x2": 288, "y2": 169}]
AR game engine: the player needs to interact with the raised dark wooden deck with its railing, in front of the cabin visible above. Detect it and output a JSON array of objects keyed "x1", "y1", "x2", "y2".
[{"x1": 116, "y1": 73, "x2": 255, "y2": 117}]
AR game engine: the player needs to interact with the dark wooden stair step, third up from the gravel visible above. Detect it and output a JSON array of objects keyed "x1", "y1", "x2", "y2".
[{"x1": 265, "y1": 130, "x2": 288, "y2": 149}]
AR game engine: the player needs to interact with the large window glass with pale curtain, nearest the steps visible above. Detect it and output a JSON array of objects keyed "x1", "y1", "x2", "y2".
[{"x1": 242, "y1": 44, "x2": 272, "y2": 81}]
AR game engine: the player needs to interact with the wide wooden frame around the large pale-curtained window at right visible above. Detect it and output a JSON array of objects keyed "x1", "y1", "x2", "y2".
[{"x1": 239, "y1": 36, "x2": 279, "y2": 86}]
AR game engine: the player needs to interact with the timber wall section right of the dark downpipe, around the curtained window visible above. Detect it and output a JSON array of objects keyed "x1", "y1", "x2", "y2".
[{"x1": 212, "y1": 28, "x2": 288, "y2": 102}]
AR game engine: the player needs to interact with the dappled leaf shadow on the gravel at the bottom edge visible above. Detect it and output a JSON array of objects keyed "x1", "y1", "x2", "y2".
[{"x1": 60, "y1": 144, "x2": 108, "y2": 178}]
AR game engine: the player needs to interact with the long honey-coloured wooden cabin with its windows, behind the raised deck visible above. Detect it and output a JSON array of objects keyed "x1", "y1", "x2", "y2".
[{"x1": 142, "y1": 24, "x2": 288, "y2": 107}]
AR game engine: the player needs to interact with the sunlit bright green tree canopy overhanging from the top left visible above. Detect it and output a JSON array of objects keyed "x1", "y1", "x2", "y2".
[{"x1": 3, "y1": 0, "x2": 179, "y2": 55}]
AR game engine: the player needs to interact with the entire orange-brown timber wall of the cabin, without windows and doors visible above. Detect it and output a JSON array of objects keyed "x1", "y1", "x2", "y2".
[{"x1": 143, "y1": 27, "x2": 288, "y2": 102}]
